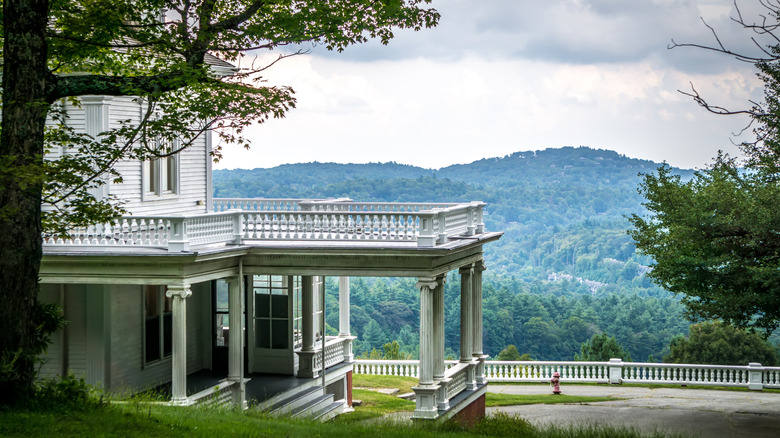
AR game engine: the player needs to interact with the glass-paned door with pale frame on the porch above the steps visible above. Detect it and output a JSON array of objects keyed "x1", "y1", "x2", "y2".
[{"x1": 247, "y1": 275, "x2": 301, "y2": 375}]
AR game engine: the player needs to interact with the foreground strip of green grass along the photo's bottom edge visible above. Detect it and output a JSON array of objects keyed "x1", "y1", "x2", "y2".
[{"x1": 0, "y1": 400, "x2": 688, "y2": 438}]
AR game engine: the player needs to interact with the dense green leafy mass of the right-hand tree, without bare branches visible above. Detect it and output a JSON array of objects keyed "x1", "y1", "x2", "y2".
[{"x1": 631, "y1": 163, "x2": 780, "y2": 333}]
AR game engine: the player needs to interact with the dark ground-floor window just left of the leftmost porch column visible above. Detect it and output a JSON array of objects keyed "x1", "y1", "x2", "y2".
[{"x1": 144, "y1": 286, "x2": 173, "y2": 363}]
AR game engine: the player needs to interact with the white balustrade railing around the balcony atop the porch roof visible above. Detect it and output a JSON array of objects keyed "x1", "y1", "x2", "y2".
[{"x1": 43, "y1": 198, "x2": 485, "y2": 252}]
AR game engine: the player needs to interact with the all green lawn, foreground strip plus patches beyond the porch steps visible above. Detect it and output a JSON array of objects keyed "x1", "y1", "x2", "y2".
[{"x1": 0, "y1": 376, "x2": 684, "y2": 438}]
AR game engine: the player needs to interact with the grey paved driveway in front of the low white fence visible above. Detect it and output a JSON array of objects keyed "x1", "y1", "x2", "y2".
[{"x1": 487, "y1": 383, "x2": 780, "y2": 438}]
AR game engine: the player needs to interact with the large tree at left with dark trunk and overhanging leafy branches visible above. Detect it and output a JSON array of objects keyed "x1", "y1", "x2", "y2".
[{"x1": 0, "y1": 0, "x2": 439, "y2": 404}]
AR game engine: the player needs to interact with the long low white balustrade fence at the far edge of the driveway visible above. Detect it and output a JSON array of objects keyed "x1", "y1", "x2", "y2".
[{"x1": 354, "y1": 359, "x2": 780, "y2": 390}]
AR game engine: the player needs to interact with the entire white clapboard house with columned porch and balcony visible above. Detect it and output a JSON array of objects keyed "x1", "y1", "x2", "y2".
[{"x1": 40, "y1": 96, "x2": 501, "y2": 419}]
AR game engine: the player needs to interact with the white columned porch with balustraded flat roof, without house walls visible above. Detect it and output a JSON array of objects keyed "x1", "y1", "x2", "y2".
[{"x1": 41, "y1": 199, "x2": 501, "y2": 419}]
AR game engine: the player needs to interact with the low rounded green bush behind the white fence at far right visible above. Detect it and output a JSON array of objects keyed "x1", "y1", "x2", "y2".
[{"x1": 664, "y1": 322, "x2": 780, "y2": 366}]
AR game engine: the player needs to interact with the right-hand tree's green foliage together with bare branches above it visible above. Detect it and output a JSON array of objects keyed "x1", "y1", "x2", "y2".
[{"x1": 631, "y1": 6, "x2": 780, "y2": 335}]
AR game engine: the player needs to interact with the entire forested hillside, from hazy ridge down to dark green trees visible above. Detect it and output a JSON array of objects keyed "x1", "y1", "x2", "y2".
[{"x1": 214, "y1": 147, "x2": 690, "y2": 360}]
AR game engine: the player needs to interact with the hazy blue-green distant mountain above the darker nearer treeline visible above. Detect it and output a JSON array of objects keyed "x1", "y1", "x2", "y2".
[{"x1": 214, "y1": 147, "x2": 691, "y2": 293}]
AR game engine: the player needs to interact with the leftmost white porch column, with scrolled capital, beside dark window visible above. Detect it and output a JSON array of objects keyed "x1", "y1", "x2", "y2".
[{"x1": 165, "y1": 283, "x2": 192, "y2": 405}]
